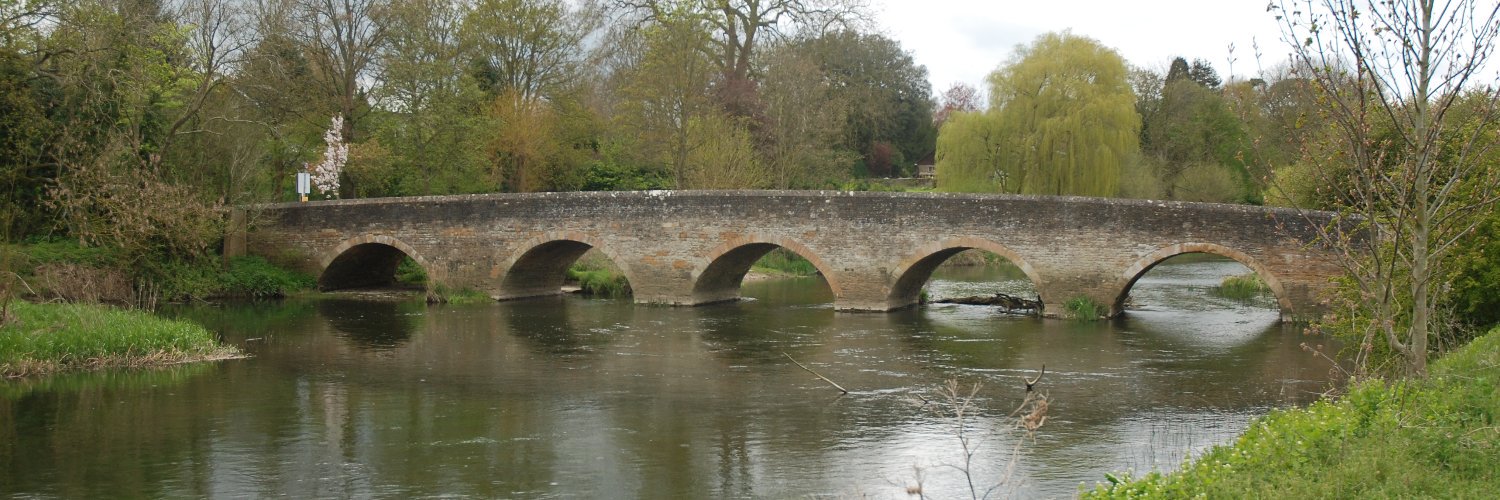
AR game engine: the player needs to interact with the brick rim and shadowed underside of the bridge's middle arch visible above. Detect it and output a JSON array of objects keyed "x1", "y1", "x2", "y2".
[{"x1": 692, "y1": 234, "x2": 843, "y2": 305}]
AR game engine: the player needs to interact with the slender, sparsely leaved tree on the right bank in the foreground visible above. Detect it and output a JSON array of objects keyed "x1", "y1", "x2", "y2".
[{"x1": 1271, "y1": 0, "x2": 1500, "y2": 377}]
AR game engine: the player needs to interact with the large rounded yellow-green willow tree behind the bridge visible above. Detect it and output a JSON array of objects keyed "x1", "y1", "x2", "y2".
[{"x1": 938, "y1": 32, "x2": 1140, "y2": 197}]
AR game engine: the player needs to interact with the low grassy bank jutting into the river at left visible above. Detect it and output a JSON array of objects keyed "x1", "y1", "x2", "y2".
[{"x1": 0, "y1": 302, "x2": 240, "y2": 378}]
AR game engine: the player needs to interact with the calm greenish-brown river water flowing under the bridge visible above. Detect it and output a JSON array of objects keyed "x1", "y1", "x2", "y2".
[{"x1": 0, "y1": 255, "x2": 1331, "y2": 498}]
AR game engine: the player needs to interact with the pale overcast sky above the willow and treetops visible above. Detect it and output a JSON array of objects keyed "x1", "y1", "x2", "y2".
[{"x1": 875, "y1": 0, "x2": 1287, "y2": 93}]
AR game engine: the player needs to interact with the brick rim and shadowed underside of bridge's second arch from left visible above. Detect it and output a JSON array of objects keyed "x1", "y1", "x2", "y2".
[{"x1": 491, "y1": 231, "x2": 636, "y2": 300}]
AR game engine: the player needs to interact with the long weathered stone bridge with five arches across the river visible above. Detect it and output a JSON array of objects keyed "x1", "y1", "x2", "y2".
[{"x1": 230, "y1": 191, "x2": 1341, "y2": 318}]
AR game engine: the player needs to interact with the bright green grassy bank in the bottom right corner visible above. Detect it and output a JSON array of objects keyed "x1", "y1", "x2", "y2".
[{"x1": 1085, "y1": 329, "x2": 1500, "y2": 498}]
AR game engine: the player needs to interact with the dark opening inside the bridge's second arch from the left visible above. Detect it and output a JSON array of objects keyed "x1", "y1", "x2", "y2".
[{"x1": 500, "y1": 240, "x2": 630, "y2": 299}]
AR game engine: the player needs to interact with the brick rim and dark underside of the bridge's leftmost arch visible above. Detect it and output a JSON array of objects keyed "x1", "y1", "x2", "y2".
[{"x1": 318, "y1": 233, "x2": 438, "y2": 290}]
